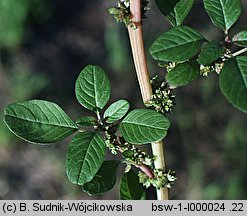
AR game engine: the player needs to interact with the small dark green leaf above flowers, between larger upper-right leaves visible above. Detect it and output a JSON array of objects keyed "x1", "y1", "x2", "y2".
[{"x1": 198, "y1": 41, "x2": 225, "y2": 65}]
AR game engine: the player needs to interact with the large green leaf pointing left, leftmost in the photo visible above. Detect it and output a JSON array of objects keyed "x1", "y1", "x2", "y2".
[{"x1": 4, "y1": 100, "x2": 78, "y2": 144}]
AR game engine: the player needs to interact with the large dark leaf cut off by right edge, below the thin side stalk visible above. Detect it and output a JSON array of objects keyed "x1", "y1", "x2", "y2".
[{"x1": 220, "y1": 56, "x2": 247, "y2": 112}]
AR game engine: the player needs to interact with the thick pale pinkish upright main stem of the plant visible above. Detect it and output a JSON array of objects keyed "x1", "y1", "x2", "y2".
[{"x1": 128, "y1": 0, "x2": 169, "y2": 200}]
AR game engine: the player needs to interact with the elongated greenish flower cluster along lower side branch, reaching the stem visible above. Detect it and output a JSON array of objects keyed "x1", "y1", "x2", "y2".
[{"x1": 102, "y1": 124, "x2": 177, "y2": 188}]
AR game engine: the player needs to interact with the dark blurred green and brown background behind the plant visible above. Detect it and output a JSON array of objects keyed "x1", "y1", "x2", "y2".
[{"x1": 0, "y1": 0, "x2": 247, "y2": 199}]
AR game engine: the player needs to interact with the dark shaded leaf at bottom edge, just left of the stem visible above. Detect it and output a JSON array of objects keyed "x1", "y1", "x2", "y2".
[{"x1": 120, "y1": 170, "x2": 145, "y2": 200}]
